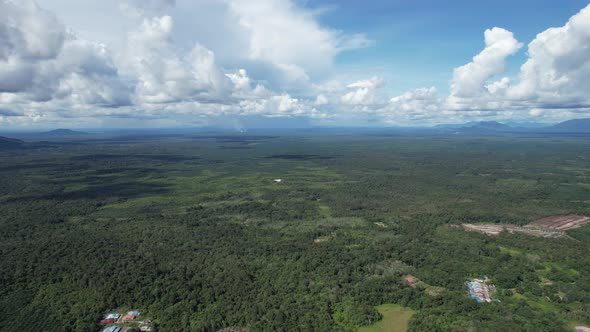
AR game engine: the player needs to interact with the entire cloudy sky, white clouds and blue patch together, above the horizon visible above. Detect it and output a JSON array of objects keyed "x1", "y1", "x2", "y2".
[{"x1": 0, "y1": 0, "x2": 590, "y2": 130}]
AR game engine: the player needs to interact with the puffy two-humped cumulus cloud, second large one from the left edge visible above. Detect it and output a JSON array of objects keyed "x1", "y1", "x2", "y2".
[{"x1": 127, "y1": 16, "x2": 231, "y2": 104}]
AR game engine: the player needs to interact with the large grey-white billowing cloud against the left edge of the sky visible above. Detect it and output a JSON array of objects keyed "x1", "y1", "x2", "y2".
[{"x1": 0, "y1": 0, "x2": 129, "y2": 107}]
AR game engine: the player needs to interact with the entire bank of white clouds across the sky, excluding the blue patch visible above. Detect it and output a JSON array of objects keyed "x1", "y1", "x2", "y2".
[{"x1": 0, "y1": 0, "x2": 590, "y2": 124}]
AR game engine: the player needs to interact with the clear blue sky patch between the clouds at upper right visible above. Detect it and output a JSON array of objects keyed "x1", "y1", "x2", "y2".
[{"x1": 324, "y1": 0, "x2": 588, "y2": 93}]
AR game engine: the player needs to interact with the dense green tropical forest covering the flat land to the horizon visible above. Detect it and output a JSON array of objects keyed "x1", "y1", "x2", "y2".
[{"x1": 0, "y1": 133, "x2": 590, "y2": 331}]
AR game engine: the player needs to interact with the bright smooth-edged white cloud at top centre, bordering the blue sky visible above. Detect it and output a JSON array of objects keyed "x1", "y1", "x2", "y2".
[{"x1": 224, "y1": 0, "x2": 371, "y2": 80}]
